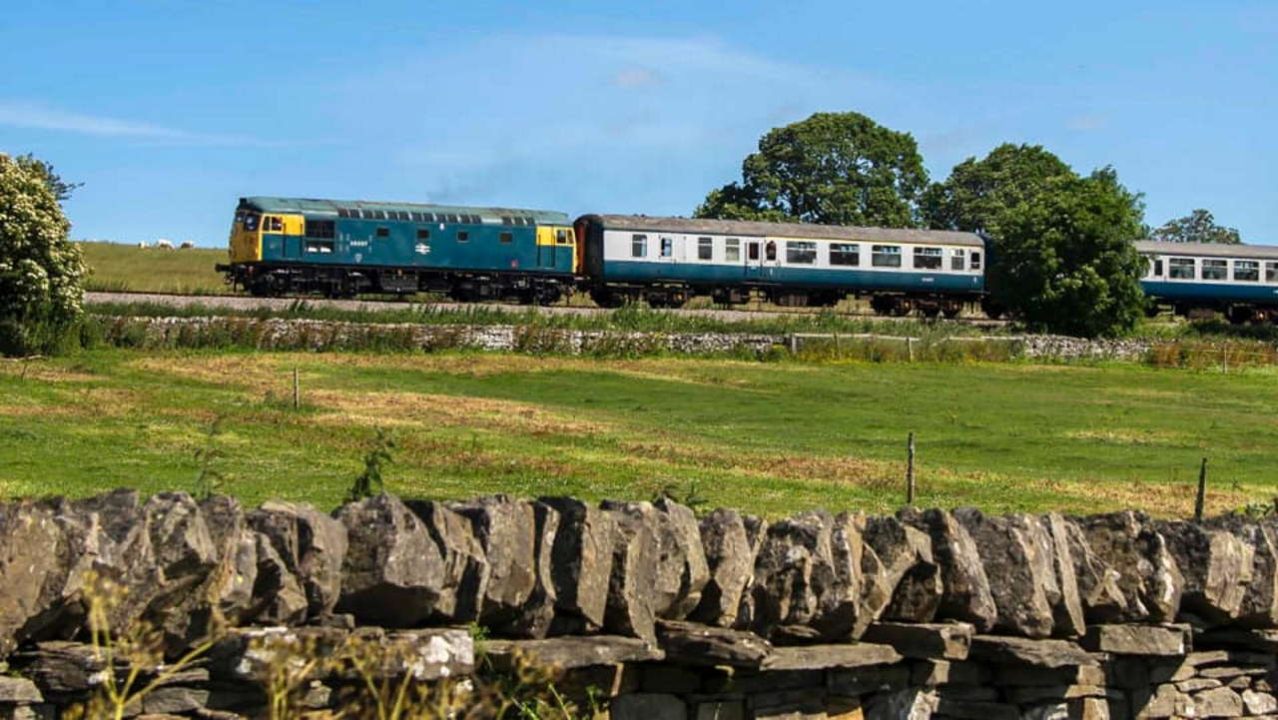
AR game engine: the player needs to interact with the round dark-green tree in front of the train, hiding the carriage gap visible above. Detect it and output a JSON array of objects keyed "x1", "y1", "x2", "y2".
[{"x1": 988, "y1": 168, "x2": 1145, "y2": 338}]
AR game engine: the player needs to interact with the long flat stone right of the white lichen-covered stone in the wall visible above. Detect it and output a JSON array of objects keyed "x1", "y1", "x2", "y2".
[{"x1": 482, "y1": 636, "x2": 666, "y2": 670}]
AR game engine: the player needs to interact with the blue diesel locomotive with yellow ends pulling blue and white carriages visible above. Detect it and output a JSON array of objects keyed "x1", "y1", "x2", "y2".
[{"x1": 217, "y1": 197, "x2": 1278, "y2": 322}]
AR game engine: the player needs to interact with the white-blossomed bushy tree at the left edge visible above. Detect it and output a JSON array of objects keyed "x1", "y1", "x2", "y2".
[{"x1": 0, "y1": 153, "x2": 86, "y2": 354}]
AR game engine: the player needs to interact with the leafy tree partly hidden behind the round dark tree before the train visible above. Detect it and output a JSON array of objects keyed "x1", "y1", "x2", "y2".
[{"x1": 923, "y1": 143, "x2": 1077, "y2": 237}]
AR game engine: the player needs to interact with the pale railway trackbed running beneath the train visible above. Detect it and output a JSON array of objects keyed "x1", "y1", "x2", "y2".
[{"x1": 84, "y1": 292, "x2": 1007, "y2": 329}]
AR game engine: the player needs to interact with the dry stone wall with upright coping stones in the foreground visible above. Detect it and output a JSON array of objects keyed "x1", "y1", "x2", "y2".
[{"x1": 0, "y1": 490, "x2": 1278, "y2": 720}]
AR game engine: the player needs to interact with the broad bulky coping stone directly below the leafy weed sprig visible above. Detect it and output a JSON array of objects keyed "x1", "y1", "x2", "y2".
[{"x1": 336, "y1": 494, "x2": 445, "y2": 628}]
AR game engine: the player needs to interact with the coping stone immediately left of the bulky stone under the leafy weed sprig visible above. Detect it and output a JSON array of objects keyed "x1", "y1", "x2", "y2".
[{"x1": 248, "y1": 500, "x2": 349, "y2": 618}]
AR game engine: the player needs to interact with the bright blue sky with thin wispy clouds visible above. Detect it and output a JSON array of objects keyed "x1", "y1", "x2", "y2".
[{"x1": 0, "y1": 0, "x2": 1278, "y2": 246}]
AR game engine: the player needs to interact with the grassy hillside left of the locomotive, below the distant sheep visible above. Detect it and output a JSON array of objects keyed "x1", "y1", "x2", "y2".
[{"x1": 78, "y1": 243, "x2": 230, "y2": 295}]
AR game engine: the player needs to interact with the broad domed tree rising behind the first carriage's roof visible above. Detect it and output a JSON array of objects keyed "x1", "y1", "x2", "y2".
[{"x1": 695, "y1": 113, "x2": 928, "y2": 228}]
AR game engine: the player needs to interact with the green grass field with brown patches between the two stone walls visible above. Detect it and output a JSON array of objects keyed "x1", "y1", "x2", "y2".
[{"x1": 0, "y1": 350, "x2": 1278, "y2": 515}]
